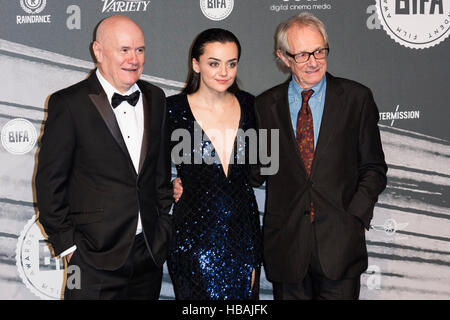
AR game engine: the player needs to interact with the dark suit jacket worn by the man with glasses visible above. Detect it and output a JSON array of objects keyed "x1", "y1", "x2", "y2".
[{"x1": 255, "y1": 73, "x2": 387, "y2": 283}]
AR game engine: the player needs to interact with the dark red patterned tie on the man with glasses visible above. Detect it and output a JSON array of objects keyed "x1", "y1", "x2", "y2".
[{"x1": 295, "y1": 89, "x2": 314, "y2": 222}]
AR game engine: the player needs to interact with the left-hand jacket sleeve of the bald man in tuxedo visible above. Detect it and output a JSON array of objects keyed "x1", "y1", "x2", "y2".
[{"x1": 35, "y1": 94, "x2": 76, "y2": 256}]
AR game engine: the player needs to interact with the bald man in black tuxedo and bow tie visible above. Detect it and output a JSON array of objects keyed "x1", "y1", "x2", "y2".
[{"x1": 36, "y1": 16, "x2": 172, "y2": 299}]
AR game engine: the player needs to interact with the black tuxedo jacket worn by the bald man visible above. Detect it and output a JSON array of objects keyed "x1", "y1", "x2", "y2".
[{"x1": 36, "y1": 72, "x2": 172, "y2": 270}]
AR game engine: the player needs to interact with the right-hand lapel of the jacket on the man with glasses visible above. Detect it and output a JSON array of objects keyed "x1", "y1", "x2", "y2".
[{"x1": 311, "y1": 73, "x2": 342, "y2": 174}]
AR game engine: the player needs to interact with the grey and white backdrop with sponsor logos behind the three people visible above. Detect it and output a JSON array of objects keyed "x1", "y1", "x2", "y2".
[{"x1": 0, "y1": 0, "x2": 450, "y2": 299}]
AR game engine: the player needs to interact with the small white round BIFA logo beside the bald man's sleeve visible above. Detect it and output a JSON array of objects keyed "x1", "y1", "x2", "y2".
[{"x1": 1, "y1": 118, "x2": 37, "y2": 155}]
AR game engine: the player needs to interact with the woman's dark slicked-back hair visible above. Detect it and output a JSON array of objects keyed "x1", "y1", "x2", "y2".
[{"x1": 183, "y1": 28, "x2": 241, "y2": 94}]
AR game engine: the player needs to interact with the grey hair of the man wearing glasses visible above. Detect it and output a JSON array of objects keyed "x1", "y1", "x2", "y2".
[{"x1": 275, "y1": 12, "x2": 328, "y2": 55}]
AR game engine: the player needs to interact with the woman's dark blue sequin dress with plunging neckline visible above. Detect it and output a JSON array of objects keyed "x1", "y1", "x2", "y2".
[{"x1": 167, "y1": 92, "x2": 262, "y2": 300}]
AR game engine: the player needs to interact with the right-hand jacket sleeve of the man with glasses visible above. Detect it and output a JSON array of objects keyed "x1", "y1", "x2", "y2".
[{"x1": 348, "y1": 90, "x2": 387, "y2": 229}]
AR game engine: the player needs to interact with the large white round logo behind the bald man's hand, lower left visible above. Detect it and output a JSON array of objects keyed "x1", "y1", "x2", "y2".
[{"x1": 16, "y1": 217, "x2": 64, "y2": 300}]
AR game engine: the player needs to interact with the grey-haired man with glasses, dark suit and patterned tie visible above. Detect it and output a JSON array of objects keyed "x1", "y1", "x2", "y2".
[{"x1": 255, "y1": 13, "x2": 387, "y2": 299}]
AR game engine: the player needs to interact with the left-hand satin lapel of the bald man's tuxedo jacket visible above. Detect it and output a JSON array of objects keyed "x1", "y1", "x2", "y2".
[{"x1": 88, "y1": 72, "x2": 133, "y2": 171}]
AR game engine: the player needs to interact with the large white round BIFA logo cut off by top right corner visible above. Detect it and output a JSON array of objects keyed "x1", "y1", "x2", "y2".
[{"x1": 376, "y1": 0, "x2": 450, "y2": 49}]
